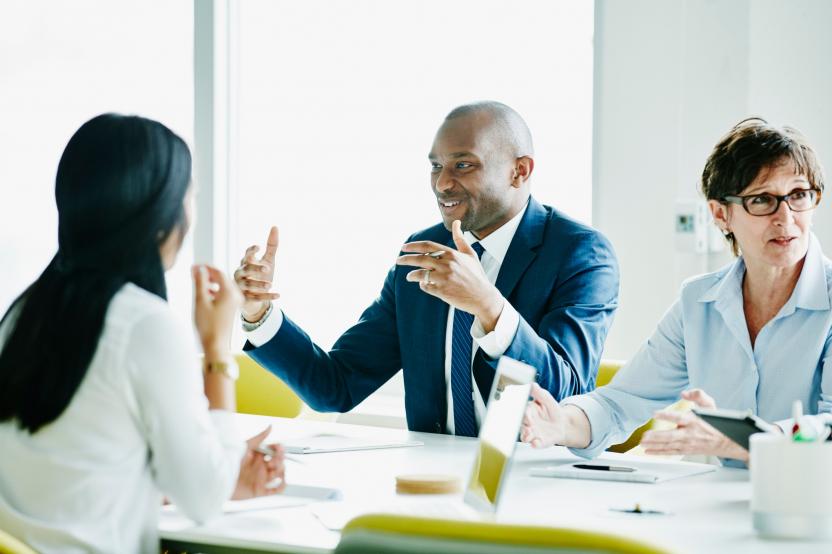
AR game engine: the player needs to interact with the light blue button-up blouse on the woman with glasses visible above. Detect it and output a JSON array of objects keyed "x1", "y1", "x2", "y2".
[{"x1": 563, "y1": 235, "x2": 832, "y2": 457}]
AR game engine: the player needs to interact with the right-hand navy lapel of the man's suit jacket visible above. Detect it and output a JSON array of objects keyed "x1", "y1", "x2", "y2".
[{"x1": 496, "y1": 198, "x2": 546, "y2": 298}]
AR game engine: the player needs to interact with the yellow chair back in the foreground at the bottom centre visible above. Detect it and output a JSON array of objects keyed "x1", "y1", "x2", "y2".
[{"x1": 335, "y1": 514, "x2": 667, "y2": 554}]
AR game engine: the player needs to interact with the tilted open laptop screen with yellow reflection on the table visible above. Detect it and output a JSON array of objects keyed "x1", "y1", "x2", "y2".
[{"x1": 465, "y1": 356, "x2": 535, "y2": 512}]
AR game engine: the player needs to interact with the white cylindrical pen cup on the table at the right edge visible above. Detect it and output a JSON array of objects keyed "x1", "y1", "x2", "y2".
[{"x1": 750, "y1": 433, "x2": 832, "y2": 539}]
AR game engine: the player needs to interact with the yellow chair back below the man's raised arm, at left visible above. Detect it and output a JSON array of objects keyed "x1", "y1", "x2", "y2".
[{"x1": 236, "y1": 354, "x2": 303, "y2": 417}]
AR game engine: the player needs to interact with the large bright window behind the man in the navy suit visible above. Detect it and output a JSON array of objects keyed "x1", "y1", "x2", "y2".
[{"x1": 232, "y1": 0, "x2": 593, "y2": 414}]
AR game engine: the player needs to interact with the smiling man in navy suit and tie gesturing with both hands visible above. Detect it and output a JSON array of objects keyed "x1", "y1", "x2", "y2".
[{"x1": 235, "y1": 102, "x2": 618, "y2": 436}]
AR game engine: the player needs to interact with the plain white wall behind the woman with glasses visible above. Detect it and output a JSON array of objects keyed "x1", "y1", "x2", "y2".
[{"x1": 593, "y1": 0, "x2": 832, "y2": 359}]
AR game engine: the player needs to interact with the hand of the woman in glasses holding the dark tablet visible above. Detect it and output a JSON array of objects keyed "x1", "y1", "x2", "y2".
[{"x1": 641, "y1": 389, "x2": 748, "y2": 462}]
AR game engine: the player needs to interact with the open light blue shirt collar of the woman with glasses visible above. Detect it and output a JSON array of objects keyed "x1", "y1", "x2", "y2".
[{"x1": 699, "y1": 233, "x2": 830, "y2": 315}]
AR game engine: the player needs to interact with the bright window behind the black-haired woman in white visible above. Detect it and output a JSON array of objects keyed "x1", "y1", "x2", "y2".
[{"x1": 0, "y1": 0, "x2": 193, "y2": 318}]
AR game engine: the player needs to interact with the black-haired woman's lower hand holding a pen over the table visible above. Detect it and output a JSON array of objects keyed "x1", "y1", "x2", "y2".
[{"x1": 231, "y1": 426, "x2": 286, "y2": 500}]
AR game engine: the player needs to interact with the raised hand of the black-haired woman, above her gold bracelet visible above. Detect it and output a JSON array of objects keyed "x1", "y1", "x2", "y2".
[{"x1": 193, "y1": 265, "x2": 243, "y2": 360}]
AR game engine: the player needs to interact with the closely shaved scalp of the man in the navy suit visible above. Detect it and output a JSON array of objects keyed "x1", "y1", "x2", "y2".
[{"x1": 445, "y1": 100, "x2": 534, "y2": 158}]
